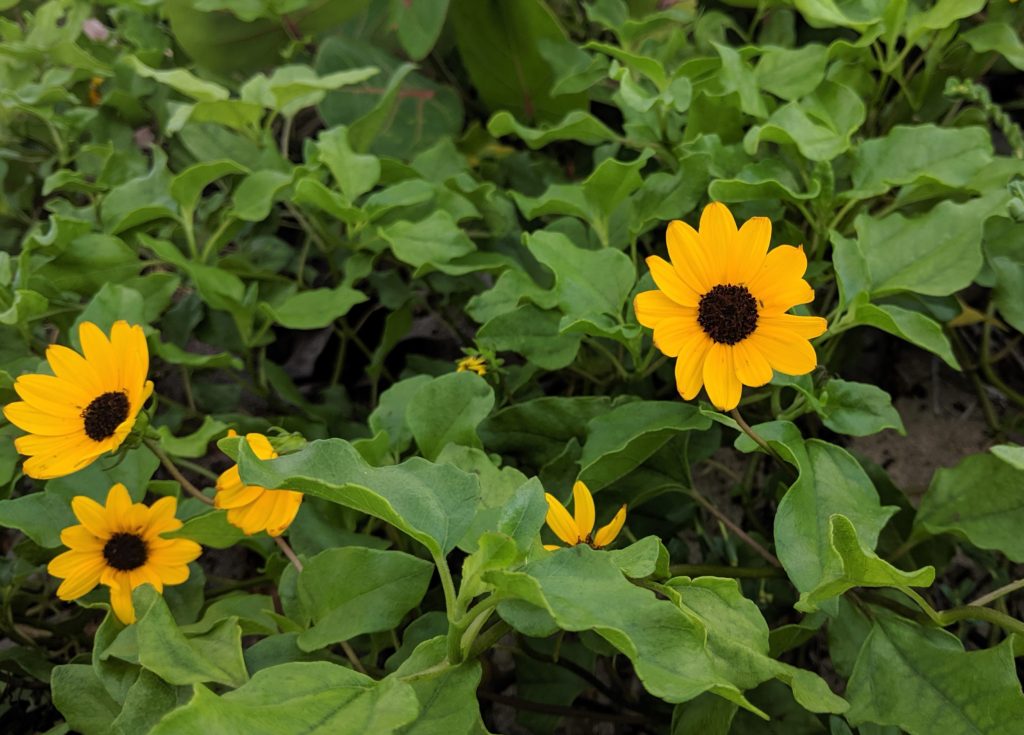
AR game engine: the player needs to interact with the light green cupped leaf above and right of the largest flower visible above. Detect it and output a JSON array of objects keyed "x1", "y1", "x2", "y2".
[{"x1": 743, "y1": 80, "x2": 866, "y2": 161}]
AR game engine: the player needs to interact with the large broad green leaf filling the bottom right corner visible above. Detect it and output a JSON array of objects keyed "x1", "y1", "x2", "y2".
[{"x1": 847, "y1": 615, "x2": 1024, "y2": 735}]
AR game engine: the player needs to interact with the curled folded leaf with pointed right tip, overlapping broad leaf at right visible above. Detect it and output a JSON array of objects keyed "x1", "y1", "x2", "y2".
[{"x1": 795, "y1": 514, "x2": 935, "y2": 612}]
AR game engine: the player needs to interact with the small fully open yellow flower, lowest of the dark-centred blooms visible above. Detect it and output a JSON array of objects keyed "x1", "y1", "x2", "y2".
[{"x1": 46, "y1": 482, "x2": 203, "y2": 624}]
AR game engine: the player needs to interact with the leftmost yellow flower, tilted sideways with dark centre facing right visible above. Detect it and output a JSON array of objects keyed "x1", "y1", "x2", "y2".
[{"x1": 3, "y1": 321, "x2": 153, "y2": 480}]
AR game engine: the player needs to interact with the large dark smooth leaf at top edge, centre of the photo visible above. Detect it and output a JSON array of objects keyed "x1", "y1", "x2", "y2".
[{"x1": 449, "y1": 0, "x2": 584, "y2": 122}]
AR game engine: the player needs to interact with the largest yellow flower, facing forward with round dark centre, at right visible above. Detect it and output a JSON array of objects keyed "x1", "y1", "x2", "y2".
[{"x1": 633, "y1": 202, "x2": 828, "y2": 410}]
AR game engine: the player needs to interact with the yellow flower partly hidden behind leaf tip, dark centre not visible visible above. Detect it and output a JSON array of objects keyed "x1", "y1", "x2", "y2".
[{"x1": 213, "y1": 429, "x2": 302, "y2": 536}]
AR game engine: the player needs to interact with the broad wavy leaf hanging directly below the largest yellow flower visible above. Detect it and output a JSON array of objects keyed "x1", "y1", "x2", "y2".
[{"x1": 736, "y1": 421, "x2": 897, "y2": 593}]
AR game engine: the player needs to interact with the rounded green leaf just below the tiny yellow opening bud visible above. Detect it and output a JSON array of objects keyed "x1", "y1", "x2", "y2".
[{"x1": 406, "y1": 371, "x2": 495, "y2": 460}]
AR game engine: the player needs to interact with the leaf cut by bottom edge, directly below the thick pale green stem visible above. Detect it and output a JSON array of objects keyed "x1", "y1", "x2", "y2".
[{"x1": 390, "y1": 636, "x2": 486, "y2": 735}]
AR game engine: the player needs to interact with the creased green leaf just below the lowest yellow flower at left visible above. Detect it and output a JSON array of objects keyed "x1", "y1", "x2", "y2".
[{"x1": 130, "y1": 585, "x2": 249, "y2": 687}]
